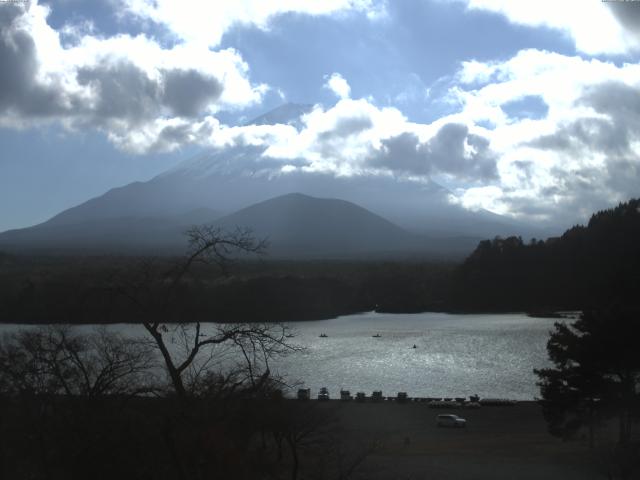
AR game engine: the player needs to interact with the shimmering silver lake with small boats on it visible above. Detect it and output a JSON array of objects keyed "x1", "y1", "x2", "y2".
[{"x1": 0, "y1": 312, "x2": 555, "y2": 400}]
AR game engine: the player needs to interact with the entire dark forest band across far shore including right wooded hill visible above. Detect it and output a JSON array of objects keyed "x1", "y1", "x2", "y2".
[{"x1": 5, "y1": 200, "x2": 640, "y2": 323}]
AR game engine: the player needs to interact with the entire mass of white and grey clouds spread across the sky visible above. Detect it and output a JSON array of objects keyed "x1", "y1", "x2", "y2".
[{"x1": 0, "y1": 0, "x2": 640, "y2": 227}]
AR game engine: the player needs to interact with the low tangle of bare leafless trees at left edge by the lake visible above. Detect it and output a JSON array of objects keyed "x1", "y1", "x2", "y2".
[{"x1": 0, "y1": 326, "x2": 154, "y2": 397}]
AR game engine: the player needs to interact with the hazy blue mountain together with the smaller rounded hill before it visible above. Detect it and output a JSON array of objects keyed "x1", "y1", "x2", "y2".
[{"x1": 0, "y1": 104, "x2": 539, "y2": 255}]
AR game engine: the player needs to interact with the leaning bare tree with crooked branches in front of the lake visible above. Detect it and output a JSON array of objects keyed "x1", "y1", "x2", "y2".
[{"x1": 113, "y1": 225, "x2": 295, "y2": 397}]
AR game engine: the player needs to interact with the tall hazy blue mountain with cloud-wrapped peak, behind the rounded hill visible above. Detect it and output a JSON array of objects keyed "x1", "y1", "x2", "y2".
[{"x1": 0, "y1": 104, "x2": 541, "y2": 255}]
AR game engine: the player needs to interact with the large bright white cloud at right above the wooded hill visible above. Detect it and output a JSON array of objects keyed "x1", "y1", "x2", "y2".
[{"x1": 439, "y1": 50, "x2": 640, "y2": 222}]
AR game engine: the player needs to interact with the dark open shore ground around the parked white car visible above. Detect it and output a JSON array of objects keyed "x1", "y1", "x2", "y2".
[{"x1": 312, "y1": 401, "x2": 603, "y2": 480}]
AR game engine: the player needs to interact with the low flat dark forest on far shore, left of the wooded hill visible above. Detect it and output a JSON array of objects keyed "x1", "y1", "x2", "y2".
[{"x1": 0, "y1": 256, "x2": 455, "y2": 323}]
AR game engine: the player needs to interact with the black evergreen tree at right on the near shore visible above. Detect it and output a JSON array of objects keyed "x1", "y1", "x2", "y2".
[{"x1": 535, "y1": 308, "x2": 640, "y2": 445}]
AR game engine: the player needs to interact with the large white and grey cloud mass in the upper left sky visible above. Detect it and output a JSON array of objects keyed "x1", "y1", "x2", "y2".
[{"x1": 0, "y1": 0, "x2": 390, "y2": 153}]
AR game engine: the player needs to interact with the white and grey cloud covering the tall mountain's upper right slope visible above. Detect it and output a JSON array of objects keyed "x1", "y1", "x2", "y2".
[{"x1": 214, "y1": 99, "x2": 498, "y2": 185}]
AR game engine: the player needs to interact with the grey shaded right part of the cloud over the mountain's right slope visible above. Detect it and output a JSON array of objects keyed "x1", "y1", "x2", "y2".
[{"x1": 372, "y1": 123, "x2": 498, "y2": 181}]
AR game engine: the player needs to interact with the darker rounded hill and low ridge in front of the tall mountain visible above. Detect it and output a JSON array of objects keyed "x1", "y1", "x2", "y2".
[{"x1": 0, "y1": 193, "x2": 478, "y2": 258}]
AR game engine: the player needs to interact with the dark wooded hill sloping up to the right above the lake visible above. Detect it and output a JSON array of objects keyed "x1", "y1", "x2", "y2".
[{"x1": 452, "y1": 200, "x2": 640, "y2": 311}]
